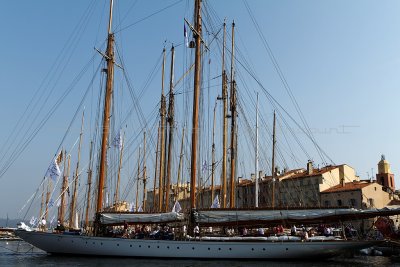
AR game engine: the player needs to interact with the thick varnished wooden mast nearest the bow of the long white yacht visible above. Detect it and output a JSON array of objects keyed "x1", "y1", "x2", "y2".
[{"x1": 96, "y1": 0, "x2": 114, "y2": 213}]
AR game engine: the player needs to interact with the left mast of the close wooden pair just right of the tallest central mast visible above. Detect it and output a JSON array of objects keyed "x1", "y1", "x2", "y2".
[{"x1": 221, "y1": 22, "x2": 228, "y2": 208}]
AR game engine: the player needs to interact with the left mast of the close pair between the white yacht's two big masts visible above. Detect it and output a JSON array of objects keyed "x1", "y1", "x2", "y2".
[{"x1": 158, "y1": 48, "x2": 166, "y2": 212}]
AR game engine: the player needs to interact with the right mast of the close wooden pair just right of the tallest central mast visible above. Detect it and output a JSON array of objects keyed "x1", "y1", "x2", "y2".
[{"x1": 229, "y1": 22, "x2": 237, "y2": 208}]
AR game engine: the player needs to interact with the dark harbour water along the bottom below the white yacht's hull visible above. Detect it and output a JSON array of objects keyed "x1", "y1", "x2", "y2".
[{"x1": 0, "y1": 241, "x2": 400, "y2": 267}]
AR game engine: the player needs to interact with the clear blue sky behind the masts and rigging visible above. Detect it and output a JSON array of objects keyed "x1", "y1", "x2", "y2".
[{"x1": 0, "y1": 0, "x2": 400, "y2": 221}]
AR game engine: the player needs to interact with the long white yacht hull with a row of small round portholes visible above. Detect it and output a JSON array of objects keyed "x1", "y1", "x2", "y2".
[{"x1": 16, "y1": 230, "x2": 375, "y2": 259}]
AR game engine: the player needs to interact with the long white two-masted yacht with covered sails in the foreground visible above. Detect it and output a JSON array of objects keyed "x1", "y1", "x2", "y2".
[{"x1": 16, "y1": 0, "x2": 388, "y2": 259}]
